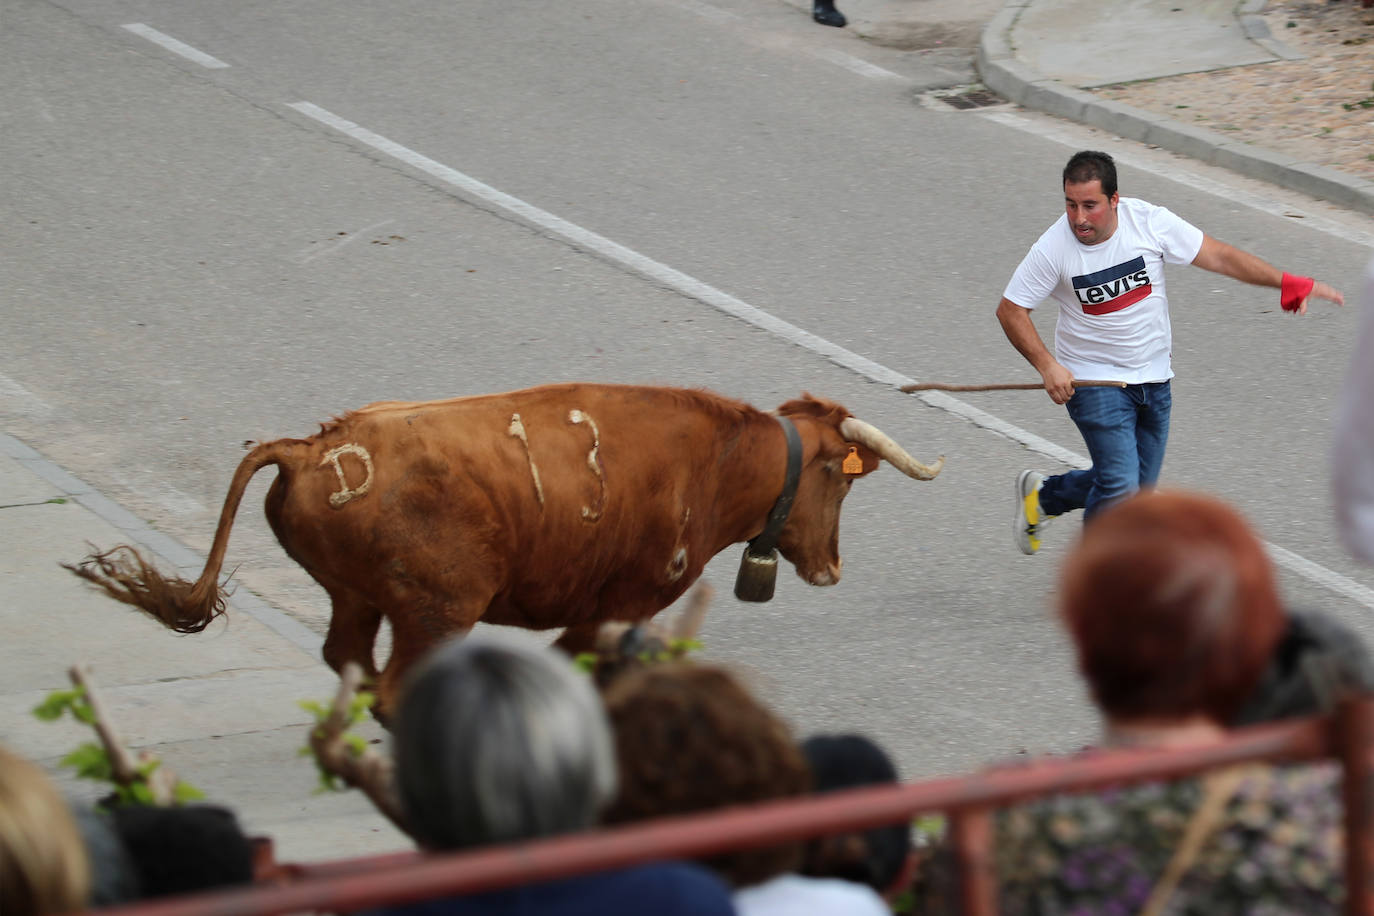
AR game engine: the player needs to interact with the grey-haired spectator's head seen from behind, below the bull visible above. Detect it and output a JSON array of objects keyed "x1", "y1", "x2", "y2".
[{"x1": 394, "y1": 636, "x2": 616, "y2": 849}]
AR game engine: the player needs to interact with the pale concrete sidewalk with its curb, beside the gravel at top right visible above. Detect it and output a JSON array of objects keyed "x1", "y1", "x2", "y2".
[{"x1": 829, "y1": 0, "x2": 1374, "y2": 214}]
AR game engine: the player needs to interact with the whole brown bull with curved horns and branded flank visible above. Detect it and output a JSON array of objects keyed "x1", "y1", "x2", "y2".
[{"x1": 70, "y1": 385, "x2": 944, "y2": 713}]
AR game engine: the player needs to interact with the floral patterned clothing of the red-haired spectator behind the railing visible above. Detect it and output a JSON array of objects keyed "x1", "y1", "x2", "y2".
[{"x1": 915, "y1": 764, "x2": 1345, "y2": 916}]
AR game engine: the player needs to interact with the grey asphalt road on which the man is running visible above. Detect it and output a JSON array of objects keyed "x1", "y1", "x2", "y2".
[{"x1": 0, "y1": 0, "x2": 1374, "y2": 791}]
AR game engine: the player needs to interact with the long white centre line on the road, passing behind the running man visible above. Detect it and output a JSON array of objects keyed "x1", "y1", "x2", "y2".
[{"x1": 290, "y1": 102, "x2": 1374, "y2": 610}]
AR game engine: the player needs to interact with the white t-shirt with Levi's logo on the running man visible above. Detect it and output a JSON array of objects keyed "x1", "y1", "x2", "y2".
[{"x1": 1002, "y1": 198, "x2": 1202, "y2": 385}]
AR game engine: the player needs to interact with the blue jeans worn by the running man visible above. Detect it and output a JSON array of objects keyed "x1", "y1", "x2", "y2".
[{"x1": 1040, "y1": 382, "x2": 1173, "y2": 522}]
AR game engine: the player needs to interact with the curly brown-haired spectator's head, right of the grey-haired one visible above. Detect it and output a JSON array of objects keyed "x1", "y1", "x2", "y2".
[{"x1": 606, "y1": 662, "x2": 811, "y2": 887}]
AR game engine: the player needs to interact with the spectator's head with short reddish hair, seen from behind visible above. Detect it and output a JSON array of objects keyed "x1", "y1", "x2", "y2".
[{"x1": 1058, "y1": 490, "x2": 1285, "y2": 725}]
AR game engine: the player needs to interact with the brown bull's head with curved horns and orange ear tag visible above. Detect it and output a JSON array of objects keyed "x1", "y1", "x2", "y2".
[{"x1": 778, "y1": 393, "x2": 944, "y2": 585}]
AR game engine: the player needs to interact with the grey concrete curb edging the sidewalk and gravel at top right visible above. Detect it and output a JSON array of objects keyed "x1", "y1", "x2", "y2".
[{"x1": 976, "y1": 0, "x2": 1374, "y2": 214}]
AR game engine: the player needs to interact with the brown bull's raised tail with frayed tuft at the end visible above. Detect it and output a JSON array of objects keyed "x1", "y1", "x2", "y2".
[{"x1": 62, "y1": 439, "x2": 304, "y2": 633}]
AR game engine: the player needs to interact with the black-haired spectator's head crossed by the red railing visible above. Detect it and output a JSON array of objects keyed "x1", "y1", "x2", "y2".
[{"x1": 801, "y1": 735, "x2": 911, "y2": 894}]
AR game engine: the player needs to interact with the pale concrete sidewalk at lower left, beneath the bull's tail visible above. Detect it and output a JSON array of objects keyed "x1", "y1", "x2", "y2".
[{"x1": 0, "y1": 433, "x2": 412, "y2": 861}]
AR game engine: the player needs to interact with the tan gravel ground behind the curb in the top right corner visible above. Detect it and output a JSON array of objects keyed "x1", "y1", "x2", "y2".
[{"x1": 1096, "y1": 0, "x2": 1374, "y2": 180}]
